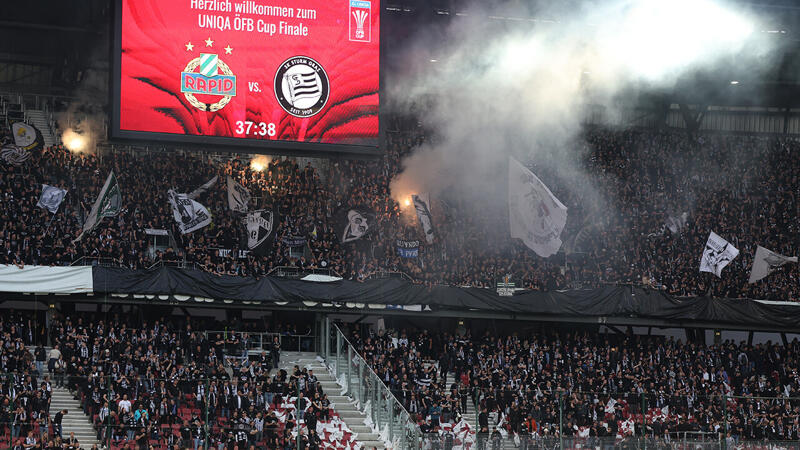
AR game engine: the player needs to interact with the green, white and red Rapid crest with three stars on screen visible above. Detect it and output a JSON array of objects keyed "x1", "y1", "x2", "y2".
[{"x1": 181, "y1": 37, "x2": 236, "y2": 112}]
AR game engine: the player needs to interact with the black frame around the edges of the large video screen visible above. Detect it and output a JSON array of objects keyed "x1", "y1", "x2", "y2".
[{"x1": 108, "y1": 0, "x2": 386, "y2": 158}]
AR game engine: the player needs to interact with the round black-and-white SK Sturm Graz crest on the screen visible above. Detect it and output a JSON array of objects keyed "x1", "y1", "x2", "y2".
[{"x1": 275, "y1": 56, "x2": 330, "y2": 118}]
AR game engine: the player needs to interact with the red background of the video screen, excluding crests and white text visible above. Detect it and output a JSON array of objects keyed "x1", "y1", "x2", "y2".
[{"x1": 119, "y1": 0, "x2": 380, "y2": 146}]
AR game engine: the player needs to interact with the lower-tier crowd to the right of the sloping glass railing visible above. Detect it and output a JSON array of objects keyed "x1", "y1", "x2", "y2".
[{"x1": 352, "y1": 330, "x2": 800, "y2": 448}]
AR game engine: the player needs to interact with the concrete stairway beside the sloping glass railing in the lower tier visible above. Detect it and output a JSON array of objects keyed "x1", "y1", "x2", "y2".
[{"x1": 280, "y1": 352, "x2": 386, "y2": 450}]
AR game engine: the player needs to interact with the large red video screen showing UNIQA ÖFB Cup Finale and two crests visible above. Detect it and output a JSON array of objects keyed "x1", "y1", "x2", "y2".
[{"x1": 111, "y1": 0, "x2": 380, "y2": 153}]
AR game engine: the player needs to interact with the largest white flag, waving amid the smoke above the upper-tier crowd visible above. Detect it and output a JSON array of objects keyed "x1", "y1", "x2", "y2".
[{"x1": 508, "y1": 158, "x2": 567, "y2": 258}]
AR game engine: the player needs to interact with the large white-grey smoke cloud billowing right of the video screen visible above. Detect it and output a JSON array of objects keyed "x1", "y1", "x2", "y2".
[{"x1": 390, "y1": 0, "x2": 754, "y2": 246}]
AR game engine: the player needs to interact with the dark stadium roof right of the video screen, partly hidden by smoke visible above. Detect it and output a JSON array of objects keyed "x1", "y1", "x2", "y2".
[{"x1": 385, "y1": 0, "x2": 800, "y2": 108}]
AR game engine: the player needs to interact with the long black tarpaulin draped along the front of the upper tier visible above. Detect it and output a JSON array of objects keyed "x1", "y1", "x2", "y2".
[{"x1": 92, "y1": 267, "x2": 800, "y2": 329}]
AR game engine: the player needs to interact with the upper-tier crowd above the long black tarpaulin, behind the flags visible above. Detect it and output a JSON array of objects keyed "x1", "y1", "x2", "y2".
[{"x1": 0, "y1": 124, "x2": 800, "y2": 301}]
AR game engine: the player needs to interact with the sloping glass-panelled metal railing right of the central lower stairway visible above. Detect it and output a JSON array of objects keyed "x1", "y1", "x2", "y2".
[{"x1": 320, "y1": 318, "x2": 422, "y2": 449}]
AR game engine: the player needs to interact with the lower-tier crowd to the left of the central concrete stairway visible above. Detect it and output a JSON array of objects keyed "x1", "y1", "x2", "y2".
[{"x1": 0, "y1": 314, "x2": 340, "y2": 449}]
